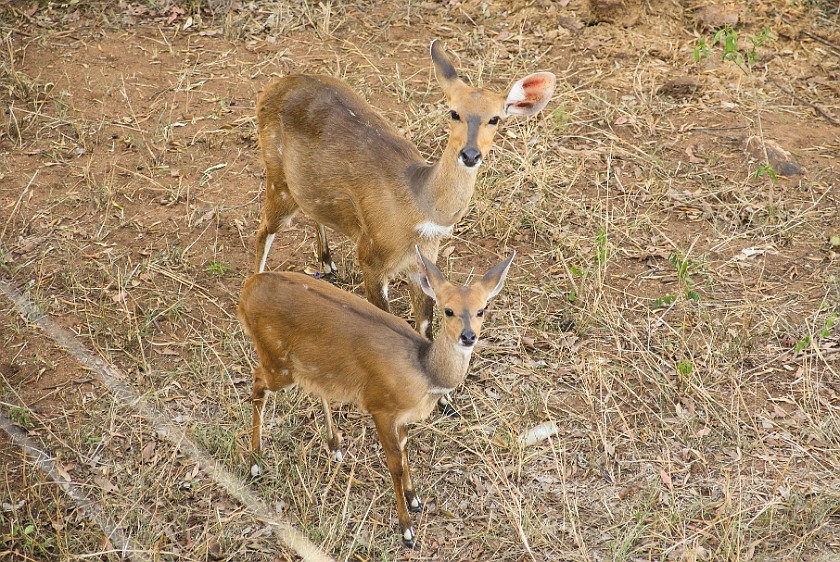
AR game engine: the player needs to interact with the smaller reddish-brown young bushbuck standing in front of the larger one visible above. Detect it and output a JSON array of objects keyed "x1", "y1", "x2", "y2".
[{"x1": 238, "y1": 248, "x2": 515, "y2": 547}]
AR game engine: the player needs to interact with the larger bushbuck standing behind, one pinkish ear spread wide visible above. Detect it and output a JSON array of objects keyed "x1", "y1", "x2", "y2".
[{"x1": 255, "y1": 41, "x2": 555, "y2": 337}]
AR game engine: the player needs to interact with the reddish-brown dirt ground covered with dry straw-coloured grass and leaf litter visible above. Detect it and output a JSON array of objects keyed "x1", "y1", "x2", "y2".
[{"x1": 0, "y1": 0, "x2": 840, "y2": 561}]
